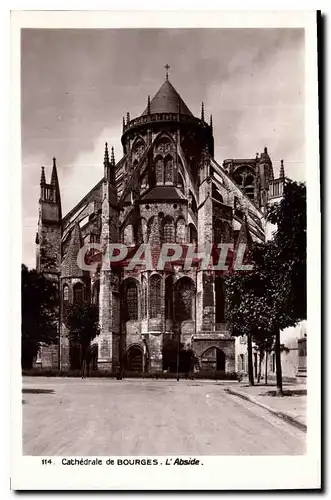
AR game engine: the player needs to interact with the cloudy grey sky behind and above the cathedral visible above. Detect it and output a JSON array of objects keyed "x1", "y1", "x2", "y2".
[{"x1": 21, "y1": 28, "x2": 305, "y2": 267}]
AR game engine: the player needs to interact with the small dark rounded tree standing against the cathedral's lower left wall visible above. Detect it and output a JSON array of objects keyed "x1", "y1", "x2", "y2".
[{"x1": 66, "y1": 302, "x2": 100, "y2": 377}]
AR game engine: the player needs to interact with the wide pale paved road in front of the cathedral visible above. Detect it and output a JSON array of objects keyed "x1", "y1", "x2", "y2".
[{"x1": 23, "y1": 377, "x2": 306, "y2": 456}]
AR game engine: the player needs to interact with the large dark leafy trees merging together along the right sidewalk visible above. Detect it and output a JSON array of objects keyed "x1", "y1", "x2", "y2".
[{"x1": 226, "y1": 181, "x2": 306, "y2": 395}]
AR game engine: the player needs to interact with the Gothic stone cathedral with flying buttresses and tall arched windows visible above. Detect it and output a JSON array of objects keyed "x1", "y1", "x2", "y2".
[{"x1": 36, "y1": 71, "x2": 284, "y2": 373}]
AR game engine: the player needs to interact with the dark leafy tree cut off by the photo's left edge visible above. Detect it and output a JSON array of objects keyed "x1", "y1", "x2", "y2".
[{"x1": 21, "y1": 264, "x2": 58, "y2": 369}]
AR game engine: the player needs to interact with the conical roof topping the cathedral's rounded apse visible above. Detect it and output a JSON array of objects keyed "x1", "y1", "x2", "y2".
[{"x1": 142, "y1": 79, "x2": 193, "y2": 116}]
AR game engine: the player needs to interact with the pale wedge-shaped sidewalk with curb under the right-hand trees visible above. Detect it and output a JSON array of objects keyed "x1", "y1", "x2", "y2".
[{"x1": 226, "y1": 382, "x2": 307, "y2": 432}]
